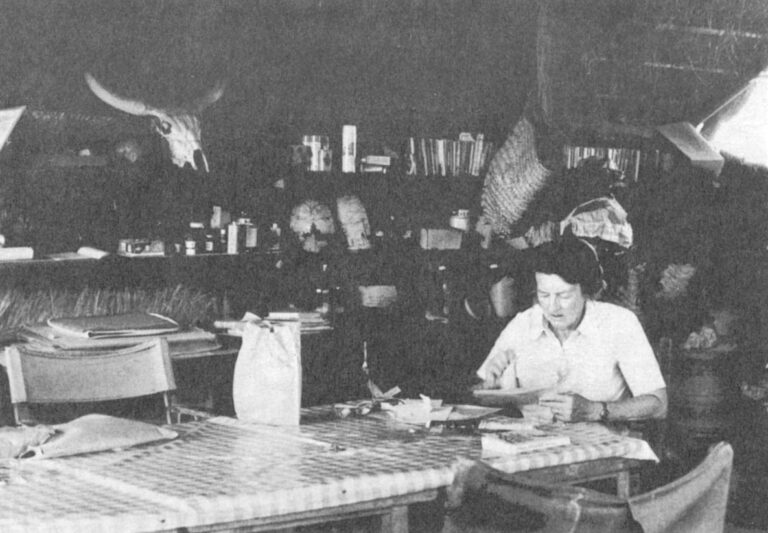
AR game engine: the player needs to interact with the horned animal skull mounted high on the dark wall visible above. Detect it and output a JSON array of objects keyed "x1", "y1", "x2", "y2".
[{"x1": 85, "y1": 73, "x2": 224, "y2": 172}]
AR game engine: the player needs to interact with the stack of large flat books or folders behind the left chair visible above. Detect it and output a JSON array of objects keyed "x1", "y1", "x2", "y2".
[{"x1": 17, "y1": 312, "x2": 221, "y2": 356}]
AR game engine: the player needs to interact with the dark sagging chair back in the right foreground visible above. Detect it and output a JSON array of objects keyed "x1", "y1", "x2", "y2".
[{"x1": 443, "y1": 442, "x2": 733, "y2": 533}]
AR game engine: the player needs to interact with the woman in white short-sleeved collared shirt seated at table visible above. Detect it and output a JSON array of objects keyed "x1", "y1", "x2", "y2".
[{"x1": 477, "y1": 237, "x2": 667, "y2": 422}]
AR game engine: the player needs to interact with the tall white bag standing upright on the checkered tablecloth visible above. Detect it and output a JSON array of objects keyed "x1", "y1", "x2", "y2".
[{"x1": 232, "y1": 321, "x2": 301, "y2": 425}]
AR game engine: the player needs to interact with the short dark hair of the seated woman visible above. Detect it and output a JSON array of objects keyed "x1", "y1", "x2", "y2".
[{"x1": 532, "y1": 237, "x2": 603, "y2": 297}]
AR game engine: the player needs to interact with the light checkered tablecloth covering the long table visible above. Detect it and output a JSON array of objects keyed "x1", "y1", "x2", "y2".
[{"x1": 0, "y1": 409, "x2": 655, "y2": 533}]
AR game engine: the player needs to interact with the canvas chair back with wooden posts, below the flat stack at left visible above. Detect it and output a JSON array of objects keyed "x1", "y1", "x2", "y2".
[{"x1": 5, "y1": 338, "x2": 176, "y2": 424}]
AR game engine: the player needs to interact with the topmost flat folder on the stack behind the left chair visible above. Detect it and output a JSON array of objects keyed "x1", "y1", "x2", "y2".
[{"x1": 48, "y1": 312, "x2": 179, "y2": 338}]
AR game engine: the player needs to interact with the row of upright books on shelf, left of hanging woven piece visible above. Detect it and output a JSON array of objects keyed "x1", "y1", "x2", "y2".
[{"x1": 405, "y1": 133, "x2": 494, "y2": 176}]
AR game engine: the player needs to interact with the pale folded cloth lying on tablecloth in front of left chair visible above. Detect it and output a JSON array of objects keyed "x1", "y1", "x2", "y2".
[{"x1": 23, "y1": 414, "x2": 178, "y2": 459}]
